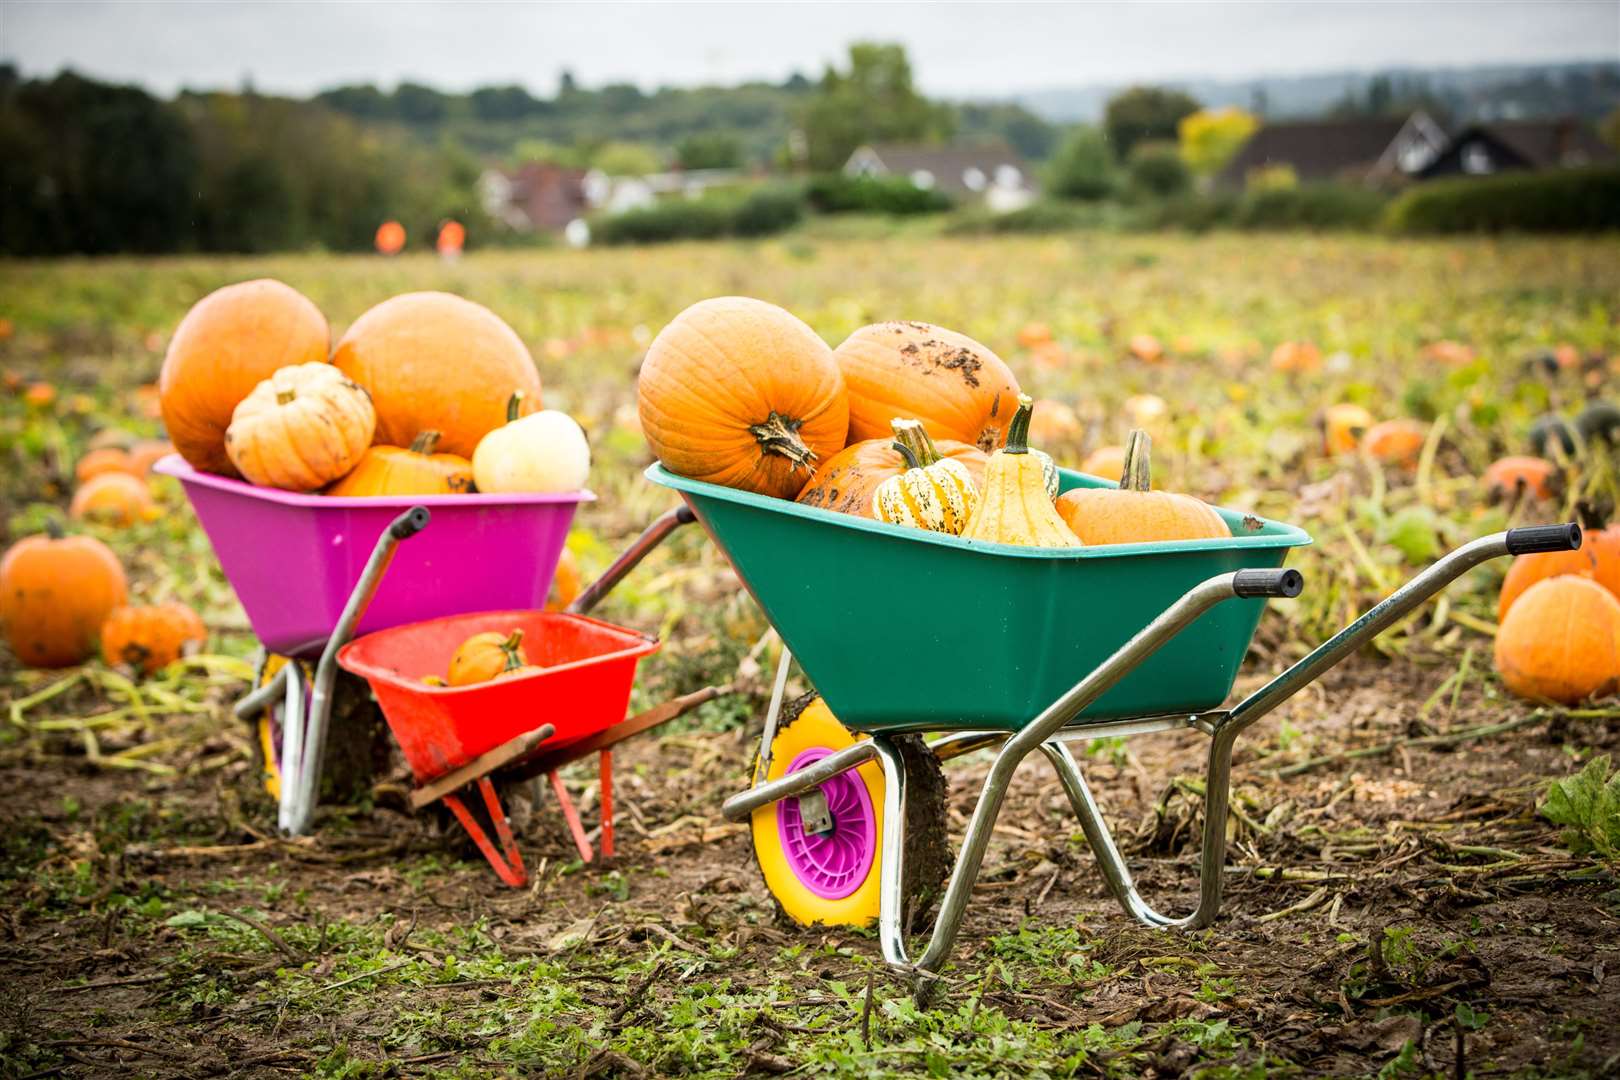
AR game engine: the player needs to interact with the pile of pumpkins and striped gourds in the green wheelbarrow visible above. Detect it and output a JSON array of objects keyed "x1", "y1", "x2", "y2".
[{"x1": 637, "y1": 296, "x2": 1231, "y2": 547}]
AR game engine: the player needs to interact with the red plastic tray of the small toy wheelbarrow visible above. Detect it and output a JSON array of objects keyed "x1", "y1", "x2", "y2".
[{"x1": 337, "y1": 610, "x2": 658, "y2": 784}]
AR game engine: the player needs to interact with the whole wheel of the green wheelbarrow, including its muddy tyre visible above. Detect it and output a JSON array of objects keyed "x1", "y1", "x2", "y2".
[{"x1": 752, "y1": 693, "x2": 951, "y2": 926}]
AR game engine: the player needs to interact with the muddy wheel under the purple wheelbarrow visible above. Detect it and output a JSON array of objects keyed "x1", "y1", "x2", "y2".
[{"x1": 253, "y1": 654, "x2": 389, "y2": 803}]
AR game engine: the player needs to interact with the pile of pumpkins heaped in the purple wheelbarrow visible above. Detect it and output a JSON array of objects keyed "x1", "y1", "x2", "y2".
[{"x1": 159, "y1": 279, "x2": 590, "y2": 497}]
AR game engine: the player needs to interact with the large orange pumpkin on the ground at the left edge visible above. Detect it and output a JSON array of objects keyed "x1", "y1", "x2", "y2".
[{"x1": 0, "y1": 536, "x2": 128, "y2": 667}]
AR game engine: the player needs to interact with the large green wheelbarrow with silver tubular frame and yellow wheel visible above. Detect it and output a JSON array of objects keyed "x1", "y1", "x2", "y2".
[{"x1": 646, "y1": 465, "x2": 1581, "y2": 991}]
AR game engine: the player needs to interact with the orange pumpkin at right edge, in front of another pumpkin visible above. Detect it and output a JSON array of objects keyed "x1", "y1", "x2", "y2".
[{"x1": 1495, "y1": 575, "x2": 1620, "y2": 704}]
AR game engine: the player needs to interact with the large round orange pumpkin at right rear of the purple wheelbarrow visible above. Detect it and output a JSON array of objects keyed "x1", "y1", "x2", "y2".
[{"x1": 332, "y1": 293, "x2": 539, "y2": 458}]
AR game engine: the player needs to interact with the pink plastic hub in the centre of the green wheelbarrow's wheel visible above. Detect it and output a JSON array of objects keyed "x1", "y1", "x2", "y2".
[{"x1": 776, "y1": 746, "x2": 878, "y2": 900}]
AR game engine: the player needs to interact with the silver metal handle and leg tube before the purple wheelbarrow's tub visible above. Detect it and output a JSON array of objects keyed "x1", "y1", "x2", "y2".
[{"x1": 233, "y1": 507, "x2": 429, "y2": 836}]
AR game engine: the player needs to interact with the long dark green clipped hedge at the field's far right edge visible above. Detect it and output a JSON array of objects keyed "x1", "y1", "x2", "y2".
[{"x1": 1385, "y1": 168, "x2": 1620, "y2": 233}]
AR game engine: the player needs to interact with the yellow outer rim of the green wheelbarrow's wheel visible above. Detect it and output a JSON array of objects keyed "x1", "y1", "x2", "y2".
[{"x1": 752, "y1": 698, "x2": 883, "y2": 926}]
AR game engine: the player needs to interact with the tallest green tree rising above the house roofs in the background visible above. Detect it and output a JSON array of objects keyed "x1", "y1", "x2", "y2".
[{"x1": 802, "y1": 42, "x2": 954, "y2": 172}]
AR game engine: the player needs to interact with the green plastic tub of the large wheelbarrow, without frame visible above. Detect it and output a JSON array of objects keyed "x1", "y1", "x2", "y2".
[{"x1": 646, "y1": 463, "x2": 1311, "y2": 732}]
